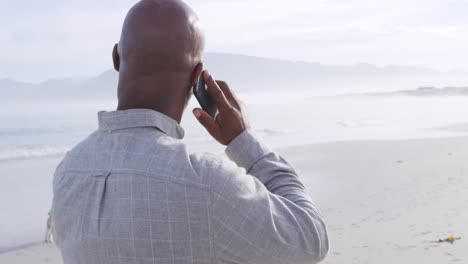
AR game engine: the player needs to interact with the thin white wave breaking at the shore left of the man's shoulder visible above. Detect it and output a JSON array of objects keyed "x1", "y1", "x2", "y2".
[{"x1": 0, "y1": 146, "x2": 70, "y2": 161}]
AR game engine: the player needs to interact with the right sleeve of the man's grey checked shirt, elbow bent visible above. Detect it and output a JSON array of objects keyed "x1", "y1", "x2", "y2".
[{"x1": 210, "y1": 131, "x2": 329, "y2": 264}]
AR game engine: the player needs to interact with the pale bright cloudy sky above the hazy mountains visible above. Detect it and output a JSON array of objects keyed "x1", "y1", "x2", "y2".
[{"x1": 0, "y1": 0, "x2": 468, "y2": 82}]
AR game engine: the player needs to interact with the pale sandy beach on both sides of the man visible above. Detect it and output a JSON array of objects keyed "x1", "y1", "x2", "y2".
[{"x1": 0, "y1": 138, "x2": 468, "y2": 264}]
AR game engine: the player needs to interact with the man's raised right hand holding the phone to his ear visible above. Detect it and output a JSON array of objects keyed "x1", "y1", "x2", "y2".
[{"x1": 193, "y1": 71, "x2": 249, "y2": 145}]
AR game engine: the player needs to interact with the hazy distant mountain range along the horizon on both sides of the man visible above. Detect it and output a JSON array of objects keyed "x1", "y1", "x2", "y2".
[{"x1": 0, "y1": 53, "x2": 468, "y2": 101}]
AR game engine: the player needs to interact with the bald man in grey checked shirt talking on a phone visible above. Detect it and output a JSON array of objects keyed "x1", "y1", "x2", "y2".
[{"x1": 51, "y1": 0, "x2": 328, "y2": 264}]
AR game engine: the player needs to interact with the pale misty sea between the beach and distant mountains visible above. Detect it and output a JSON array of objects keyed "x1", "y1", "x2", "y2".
[{"x1": 0, "y1": 91, "x2": 468, "y2": 162}]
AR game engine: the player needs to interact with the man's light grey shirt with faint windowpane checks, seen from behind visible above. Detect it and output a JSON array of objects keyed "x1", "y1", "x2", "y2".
[{"x1": 51, "y1": 109, "x2": 328, "y2": 264}]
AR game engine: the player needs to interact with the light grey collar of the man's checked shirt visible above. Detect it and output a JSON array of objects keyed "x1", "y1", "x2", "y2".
[{"x1": 98, "y1": 109, "x2": 185, "y2": 139}]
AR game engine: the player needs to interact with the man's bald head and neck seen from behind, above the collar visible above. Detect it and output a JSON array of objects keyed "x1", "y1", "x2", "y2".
[{"x1": 113, "y1": 0, "x2": 204, "y2": 120}]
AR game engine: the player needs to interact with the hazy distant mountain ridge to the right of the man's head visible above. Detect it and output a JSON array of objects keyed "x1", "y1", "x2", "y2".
[{"x1": 205, "y1": 54, "x2": 442, "y2": 93}]
